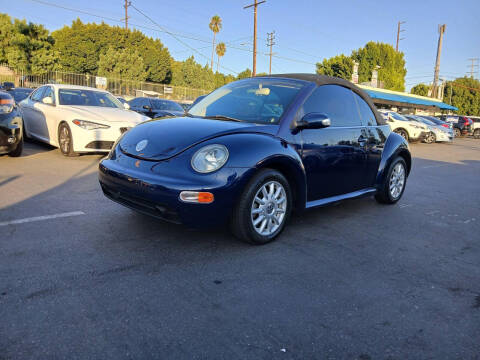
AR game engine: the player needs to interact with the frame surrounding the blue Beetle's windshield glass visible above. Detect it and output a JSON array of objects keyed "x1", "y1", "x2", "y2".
[{"x1": 185, "y1": 76, "x2": 313, "y2": 127}]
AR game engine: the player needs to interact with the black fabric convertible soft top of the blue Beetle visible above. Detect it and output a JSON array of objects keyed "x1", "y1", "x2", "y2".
[{"x1": 263, "y1": 73, "x2": 386, "y2": 125}]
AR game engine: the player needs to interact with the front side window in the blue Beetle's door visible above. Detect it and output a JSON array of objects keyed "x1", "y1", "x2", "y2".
[{"x1": 303, "y1": 85, "x2": 362, "y2": 127}]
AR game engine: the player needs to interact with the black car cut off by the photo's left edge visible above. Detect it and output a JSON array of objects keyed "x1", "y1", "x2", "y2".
[{"x1": 0, "y1": 91, "x2": 23, "y2": 157}]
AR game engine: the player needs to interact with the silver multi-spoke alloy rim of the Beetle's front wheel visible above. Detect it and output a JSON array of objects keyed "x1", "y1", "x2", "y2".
[{"x1": 250, "y1": 181, "x2": 287, "y2": 236}]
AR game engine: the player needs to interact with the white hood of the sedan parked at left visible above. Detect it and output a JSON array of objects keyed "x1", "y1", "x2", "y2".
[{"x1": 60, "y1": 105, "x2": 150, "y2": 124}]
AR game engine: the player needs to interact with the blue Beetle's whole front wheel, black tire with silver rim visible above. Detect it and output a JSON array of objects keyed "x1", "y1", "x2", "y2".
[{"x1": 231, "y1": 169, "x2": 293, "y2": 245}]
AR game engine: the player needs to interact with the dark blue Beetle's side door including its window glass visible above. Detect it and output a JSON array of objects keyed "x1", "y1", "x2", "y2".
[{"x1": 299, "y1": 85, "x2": 368, "y2": 201}]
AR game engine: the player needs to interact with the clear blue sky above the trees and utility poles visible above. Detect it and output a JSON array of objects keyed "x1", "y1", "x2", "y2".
[{"x1": 0, "y1": 0, "x2": 480, "y2": 89}]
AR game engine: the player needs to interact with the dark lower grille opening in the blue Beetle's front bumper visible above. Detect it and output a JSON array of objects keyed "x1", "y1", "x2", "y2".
[{"x1": 100, "y1": 183, "x2": 180, "y2": 224}]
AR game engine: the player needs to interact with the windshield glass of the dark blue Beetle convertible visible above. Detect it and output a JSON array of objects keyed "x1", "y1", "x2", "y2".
[{"x1": 189, "y1": 78, "x2": 305, "y2": 124}]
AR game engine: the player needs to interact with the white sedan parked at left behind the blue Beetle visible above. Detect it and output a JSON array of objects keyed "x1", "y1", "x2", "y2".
[{"x1": 19, "y1": 84, "x2": 150, "y2": 156}]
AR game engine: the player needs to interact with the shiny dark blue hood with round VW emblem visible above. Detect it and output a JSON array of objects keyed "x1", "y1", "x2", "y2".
[{"x1": 119, "y1": 117, "x2": 278, "y2": 161}]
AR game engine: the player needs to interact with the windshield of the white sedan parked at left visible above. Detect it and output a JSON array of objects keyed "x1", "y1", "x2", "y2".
[{"x1": 58, "y1": 89, "x2": 123, "y2": 109}]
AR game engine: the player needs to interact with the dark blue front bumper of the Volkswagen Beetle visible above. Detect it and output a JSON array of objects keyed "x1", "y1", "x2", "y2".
[{"x1": 99, "y1": 154, "x2": 254, "y2": 227}]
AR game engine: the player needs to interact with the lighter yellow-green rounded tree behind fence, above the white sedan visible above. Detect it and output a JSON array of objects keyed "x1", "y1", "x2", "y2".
[{"x1": 98, "y1": 48, "x2": 147, "y2": 81}]
